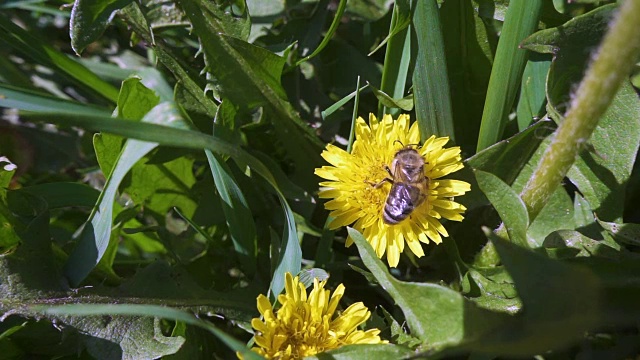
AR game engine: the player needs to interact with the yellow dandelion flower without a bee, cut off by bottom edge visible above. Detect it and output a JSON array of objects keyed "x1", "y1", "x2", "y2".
[{"x1": 238, "y1": 273, "x2": 387, "y2": 360}]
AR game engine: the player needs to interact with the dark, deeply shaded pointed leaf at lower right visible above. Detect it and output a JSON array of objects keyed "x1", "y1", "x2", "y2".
[{"x1": 485, "y1": 229, "x2": 606, "y2": 356}]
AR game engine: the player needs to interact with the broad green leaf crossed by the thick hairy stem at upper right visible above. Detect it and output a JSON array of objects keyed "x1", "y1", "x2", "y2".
[{"x1": 523, "y1": 5, "x2": 640, "y2": 222}]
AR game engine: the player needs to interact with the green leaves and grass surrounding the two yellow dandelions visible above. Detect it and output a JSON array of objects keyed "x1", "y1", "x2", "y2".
[{"x1": 0, "y1": 0, "x2": 640, "y2": 359}]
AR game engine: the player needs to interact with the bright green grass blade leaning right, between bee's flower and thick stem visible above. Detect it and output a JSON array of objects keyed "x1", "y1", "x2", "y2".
[{"x1": 477, "y1": 0, "x2": 542, "y2": 151}]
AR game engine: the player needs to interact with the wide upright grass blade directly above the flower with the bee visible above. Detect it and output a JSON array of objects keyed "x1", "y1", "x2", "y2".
[{"x1": 413, "y1": 0, "x2": 456, "y2": 142}]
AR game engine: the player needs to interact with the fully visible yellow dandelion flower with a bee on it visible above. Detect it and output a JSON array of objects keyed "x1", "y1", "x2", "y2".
[{"x1": 315, "y1": 114, "x2": 471, "y2": 267}]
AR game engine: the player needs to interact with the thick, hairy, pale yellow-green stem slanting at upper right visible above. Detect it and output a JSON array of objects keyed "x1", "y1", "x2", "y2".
[{"x1": 520, "y1": 0, "x2": 640, "y2": 222}]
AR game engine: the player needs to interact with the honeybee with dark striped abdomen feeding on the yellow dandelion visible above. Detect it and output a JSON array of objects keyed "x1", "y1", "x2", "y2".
[{"x1": 375, "y1": 145, "x2": 429, "y2": 225}]
